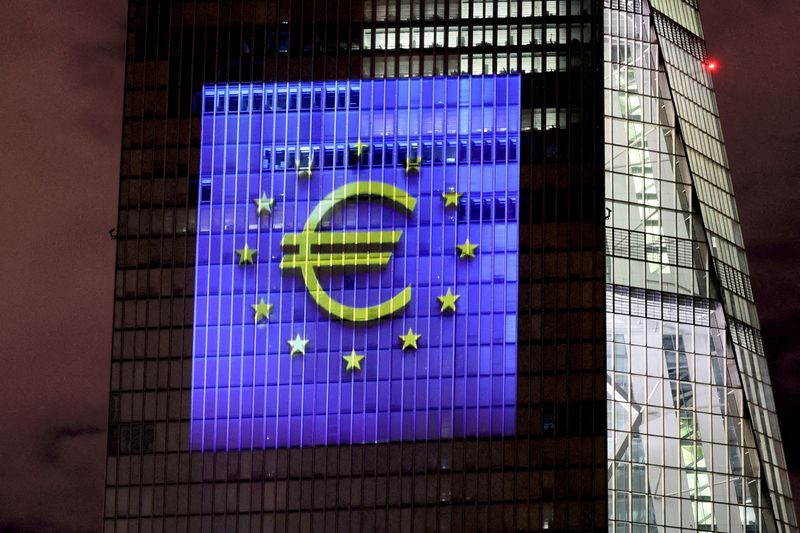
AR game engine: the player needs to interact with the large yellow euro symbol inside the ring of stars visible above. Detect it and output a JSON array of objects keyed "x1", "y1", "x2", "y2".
[{"x1": 280, "y1": 181, "x2": 417, "y2": 322}]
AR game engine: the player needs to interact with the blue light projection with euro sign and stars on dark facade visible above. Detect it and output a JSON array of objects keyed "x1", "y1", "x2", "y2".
[{"x1": 191, "y1": 75, "x2": 520, "y2": 450}]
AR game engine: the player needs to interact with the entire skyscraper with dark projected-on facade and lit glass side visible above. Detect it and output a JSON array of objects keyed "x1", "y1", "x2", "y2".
[{"x1": 104, "y1": 0, "x2": 796, "y2": 532}]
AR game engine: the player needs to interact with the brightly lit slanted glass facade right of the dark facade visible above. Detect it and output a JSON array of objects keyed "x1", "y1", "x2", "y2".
[{"x1": 604, "y1": 0, "x2": 797, "y2": 531}]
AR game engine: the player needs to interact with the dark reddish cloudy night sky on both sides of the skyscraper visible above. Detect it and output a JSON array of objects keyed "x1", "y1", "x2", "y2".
[{"x1": 0, "y1": 0, "x2": 800, "y2": 531}]
